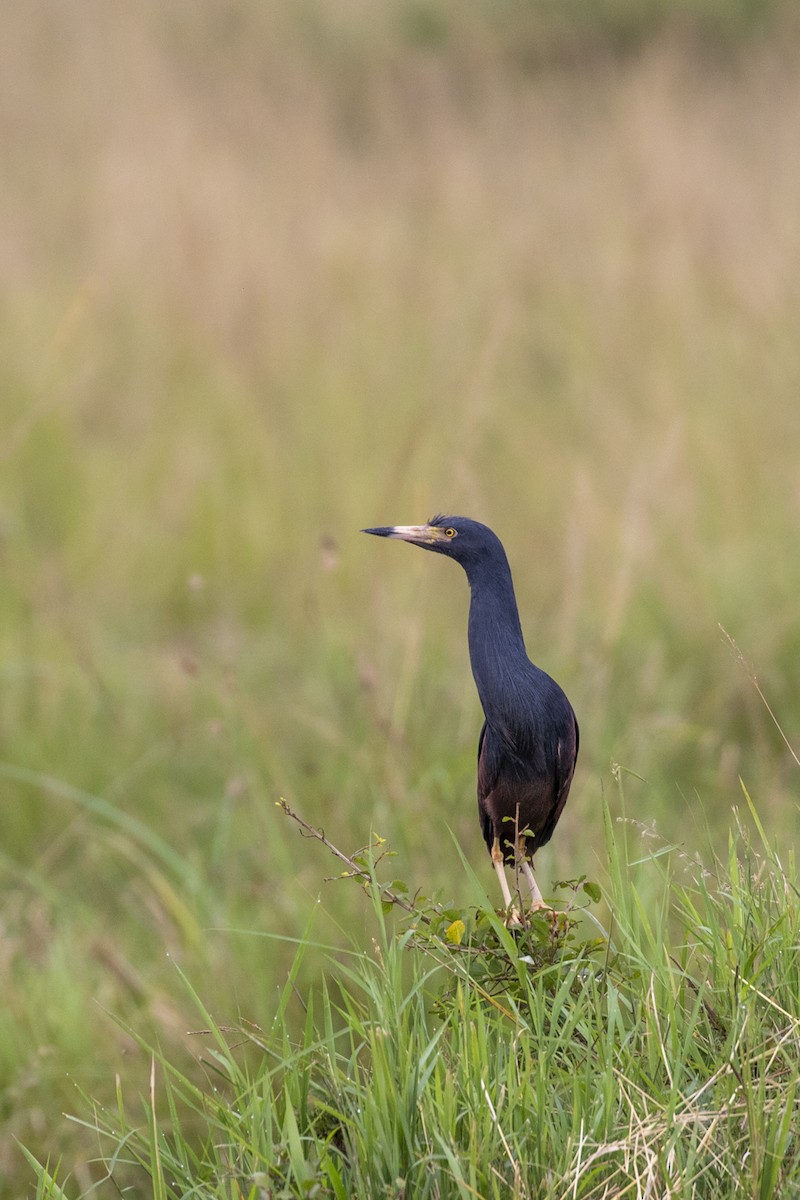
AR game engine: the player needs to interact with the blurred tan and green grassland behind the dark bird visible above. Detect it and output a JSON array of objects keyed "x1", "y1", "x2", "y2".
[{"x1": 0, "y1": 0, "x2": 800, "y2": 1196}]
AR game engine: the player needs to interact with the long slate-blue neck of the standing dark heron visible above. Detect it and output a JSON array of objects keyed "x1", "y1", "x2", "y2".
[{"x1": 467, "y1": 552, "x2": 530, "y2": 726}]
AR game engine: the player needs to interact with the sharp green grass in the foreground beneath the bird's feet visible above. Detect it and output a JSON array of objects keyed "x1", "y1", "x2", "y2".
[{"x1": 28, "y1": 792, "x2": 800, "y2": 1200}]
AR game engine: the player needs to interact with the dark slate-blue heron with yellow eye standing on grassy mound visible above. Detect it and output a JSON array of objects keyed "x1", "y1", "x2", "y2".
[{"x1": 362, "y1": 515, "x2": 579, "y2": 926}]
